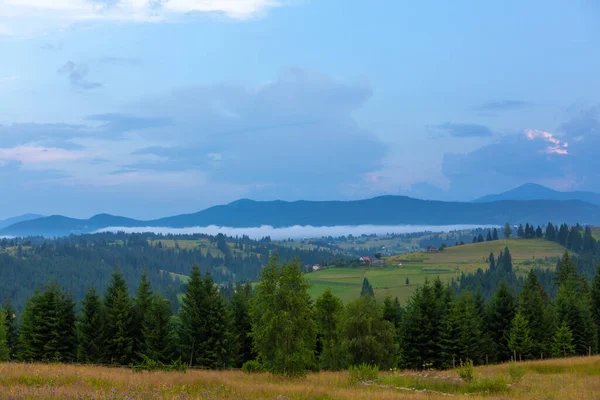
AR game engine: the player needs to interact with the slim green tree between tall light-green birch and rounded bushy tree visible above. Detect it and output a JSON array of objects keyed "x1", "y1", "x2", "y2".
[{"x1": 315, "y1": 288, "x2": 346, "y2": 371}]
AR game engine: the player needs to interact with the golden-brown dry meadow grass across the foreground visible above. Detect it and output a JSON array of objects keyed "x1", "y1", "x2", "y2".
[{"x1": 0, "y1": 356, "x2": 600, "y2": 400}]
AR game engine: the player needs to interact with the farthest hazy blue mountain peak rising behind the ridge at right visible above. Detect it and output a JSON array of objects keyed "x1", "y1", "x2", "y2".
[{"x1": 474, "y1": 183, "x2": 600, "y2": 205}]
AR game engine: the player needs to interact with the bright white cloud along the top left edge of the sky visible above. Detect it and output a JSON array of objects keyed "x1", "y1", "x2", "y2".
[{"x1": 0, "y1": 0, "x2": 283, "y2": 36}]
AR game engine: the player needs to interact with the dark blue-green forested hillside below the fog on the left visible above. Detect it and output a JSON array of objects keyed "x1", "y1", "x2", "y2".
[{"x1": 0, "y1": 233, "x2": 345, "y2": 309}]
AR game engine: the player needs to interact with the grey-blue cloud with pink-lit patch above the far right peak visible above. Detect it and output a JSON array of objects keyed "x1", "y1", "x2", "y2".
[{"x1": 442, "y1": 107, "x2": 600, "y2": 199}]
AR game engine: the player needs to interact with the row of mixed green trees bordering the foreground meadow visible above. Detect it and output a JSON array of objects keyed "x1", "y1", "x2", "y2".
[{"x1": 0, "y1": 249, "x2": 600, "y2": 376}]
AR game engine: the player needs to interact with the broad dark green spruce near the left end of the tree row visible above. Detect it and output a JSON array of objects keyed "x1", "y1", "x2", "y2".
[{"x1": 19, "y1": 285, "x2": 77, "y2": 362}]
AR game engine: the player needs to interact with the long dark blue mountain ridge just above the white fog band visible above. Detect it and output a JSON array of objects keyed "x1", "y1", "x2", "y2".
[{"x1": 0, "y1": 196, "x2": 600, "y2": 236}]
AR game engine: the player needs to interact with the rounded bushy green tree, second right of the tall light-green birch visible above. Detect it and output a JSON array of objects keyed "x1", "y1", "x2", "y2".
[{"x1": 343, "y1": 296, "x2": 397, "y2": 368}]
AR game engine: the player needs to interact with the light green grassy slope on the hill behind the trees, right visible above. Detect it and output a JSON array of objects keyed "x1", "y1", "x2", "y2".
[{"x1": 306, "y1": 239, "x2": 565, "y2": 302}]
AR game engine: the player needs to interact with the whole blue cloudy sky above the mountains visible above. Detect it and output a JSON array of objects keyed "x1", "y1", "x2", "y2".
[{"x1": 0, "y1": 0, "x2": 600, "y2": 219}]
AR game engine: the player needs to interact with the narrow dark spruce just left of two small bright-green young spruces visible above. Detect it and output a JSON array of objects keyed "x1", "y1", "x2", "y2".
[{"x1": 486, "y1": 280, "x2": 515, "y2": 362}]
